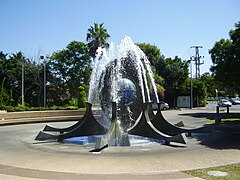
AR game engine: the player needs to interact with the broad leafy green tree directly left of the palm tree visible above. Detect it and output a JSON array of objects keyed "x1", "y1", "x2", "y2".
[{"x1": 48, "y1": 41, "x2": 91, "y2": 103}]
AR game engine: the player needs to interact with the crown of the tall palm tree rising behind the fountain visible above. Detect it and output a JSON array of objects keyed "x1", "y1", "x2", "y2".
[{"x1": 86, "y1": 23, "x2": 110, "y2": 58}]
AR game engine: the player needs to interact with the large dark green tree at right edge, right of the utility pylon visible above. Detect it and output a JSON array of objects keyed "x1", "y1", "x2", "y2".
[{"x1": 209, "y1": 22, "x2": 240, "y2": 93}]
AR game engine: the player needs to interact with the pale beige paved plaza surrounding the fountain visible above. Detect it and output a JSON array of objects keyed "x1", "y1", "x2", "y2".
[{"x1": 0, "y1": 107, "x2": 240, "y2": 180}]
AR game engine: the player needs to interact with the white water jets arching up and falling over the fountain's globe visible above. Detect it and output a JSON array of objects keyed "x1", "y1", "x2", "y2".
[{"x1": 88, "y1": 36, "x2": 159, "y2": 129}]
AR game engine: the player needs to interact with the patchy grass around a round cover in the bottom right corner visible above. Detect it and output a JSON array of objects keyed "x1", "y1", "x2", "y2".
[{"x1": 184, "y1": 163, "x2": 240, "y2": 180}]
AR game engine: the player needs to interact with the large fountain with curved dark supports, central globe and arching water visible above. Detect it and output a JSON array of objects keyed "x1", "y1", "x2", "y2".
[{"x1": 36, "y1": 36, "x2": 208, "y2": 150}]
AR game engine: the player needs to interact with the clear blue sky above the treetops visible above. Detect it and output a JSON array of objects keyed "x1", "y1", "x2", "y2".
[{"x1": 0, "y1": 0, "x2": 240, "y2": 73}]
